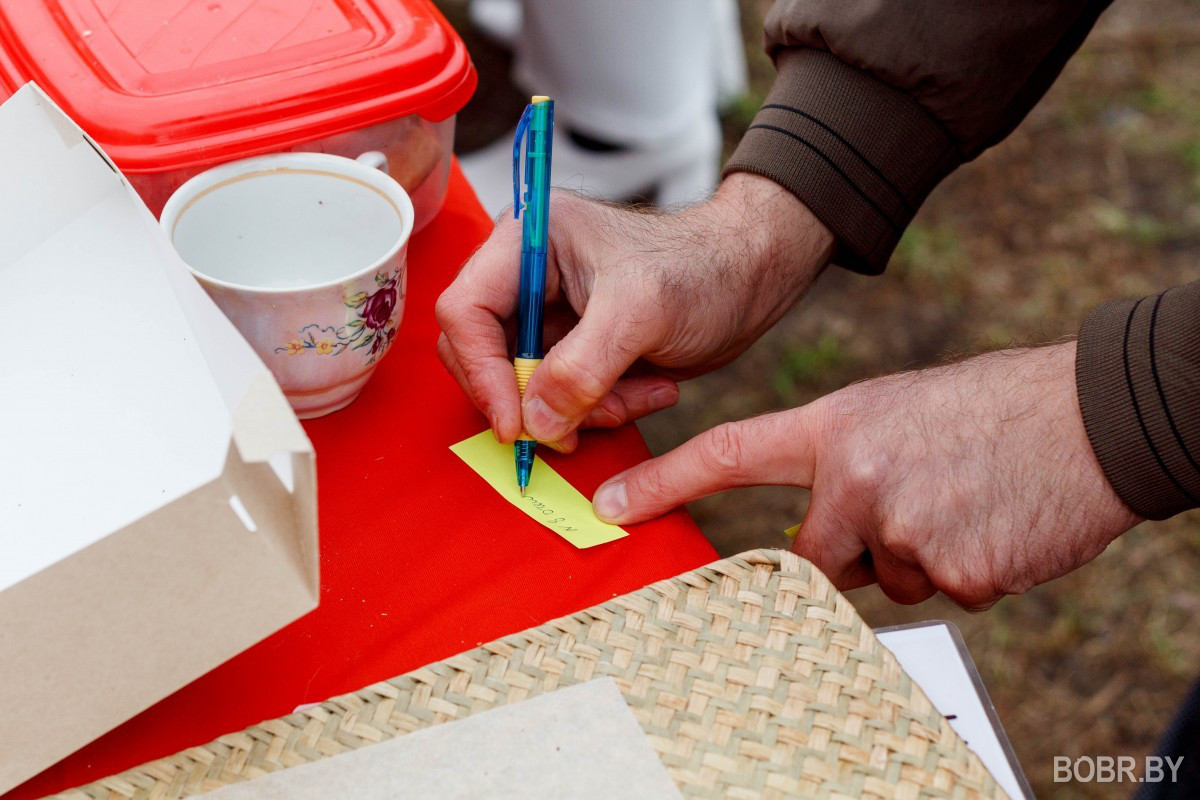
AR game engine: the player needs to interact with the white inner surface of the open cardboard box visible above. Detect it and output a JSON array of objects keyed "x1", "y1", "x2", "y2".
[{"x1": 0, "y1": 84, "x2": 312, "y2": 591}]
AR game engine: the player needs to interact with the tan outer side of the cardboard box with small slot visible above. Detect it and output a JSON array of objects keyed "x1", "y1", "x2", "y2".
[{"x1": 0, "y1": 445, "x2": 319, "y2": 794}]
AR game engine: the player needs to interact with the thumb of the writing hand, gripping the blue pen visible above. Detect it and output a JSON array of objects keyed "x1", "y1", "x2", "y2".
[{"x1": 522, "y1": 297, "x2": 650, "y2": 441}]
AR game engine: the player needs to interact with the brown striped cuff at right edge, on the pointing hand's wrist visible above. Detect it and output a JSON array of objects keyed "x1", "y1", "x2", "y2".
[{"x1": 1075, "y1": 283, "x2": 1200, "y2": 519}]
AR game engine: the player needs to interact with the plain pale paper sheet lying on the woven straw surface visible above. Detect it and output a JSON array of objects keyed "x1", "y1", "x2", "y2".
[{"x1": 204, "y1": 676, "x2": 683, "y2": 800}]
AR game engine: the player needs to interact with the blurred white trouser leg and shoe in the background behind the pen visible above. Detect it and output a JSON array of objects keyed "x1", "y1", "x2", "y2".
[{"x1": 462, "y1": 0, "x2": 745, "y2": 213}]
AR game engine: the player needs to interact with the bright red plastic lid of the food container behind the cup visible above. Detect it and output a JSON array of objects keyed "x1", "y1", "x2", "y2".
[{"x1": 0, "y1": 0, "x2": 476, "y2": 173}]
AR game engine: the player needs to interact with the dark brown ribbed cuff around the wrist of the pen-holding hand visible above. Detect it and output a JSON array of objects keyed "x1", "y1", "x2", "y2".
[{"x1": 722, "y1": 48, "x2": 962, "y2": 275}]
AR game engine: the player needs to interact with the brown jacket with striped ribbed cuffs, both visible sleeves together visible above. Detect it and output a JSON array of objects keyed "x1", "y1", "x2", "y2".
[{"x1": 725, "y1": 0, "x2": 1200, "y2": 519}]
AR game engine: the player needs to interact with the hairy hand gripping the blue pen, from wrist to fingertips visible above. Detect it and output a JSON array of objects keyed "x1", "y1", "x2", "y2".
[{"x1": 437, "y1": 174, "x2": 833, "y2": 482}]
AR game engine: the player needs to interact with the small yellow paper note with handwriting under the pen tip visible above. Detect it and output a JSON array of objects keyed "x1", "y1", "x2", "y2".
[{"x1": 450, "y1": 431, "x2": 629, "y2": 549}]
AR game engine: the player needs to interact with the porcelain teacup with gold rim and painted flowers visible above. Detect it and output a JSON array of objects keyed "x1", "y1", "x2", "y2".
[{"x1": 161, "y1": 152, "x2": 414, "y2": 419}]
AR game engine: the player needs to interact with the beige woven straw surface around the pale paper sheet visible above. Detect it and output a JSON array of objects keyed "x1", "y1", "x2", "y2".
[{"x1": 65, "y1": 551, "x2": 1004, "y2": 800}]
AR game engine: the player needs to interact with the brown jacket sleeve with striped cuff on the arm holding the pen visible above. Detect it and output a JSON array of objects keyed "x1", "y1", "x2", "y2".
[{"x1": 725, "y1": 0, "x2": 1109, "y2": 273}]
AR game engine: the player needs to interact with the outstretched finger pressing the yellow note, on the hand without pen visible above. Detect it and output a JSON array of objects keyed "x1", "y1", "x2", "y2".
[{"x1": 593, "y1": 407, "x2": 818, "y2": 524}]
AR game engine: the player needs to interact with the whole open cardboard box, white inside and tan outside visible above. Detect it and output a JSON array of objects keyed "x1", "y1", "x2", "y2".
[{"x1": 0, "y1": 85, "x2": 318, "y2": 793}]
